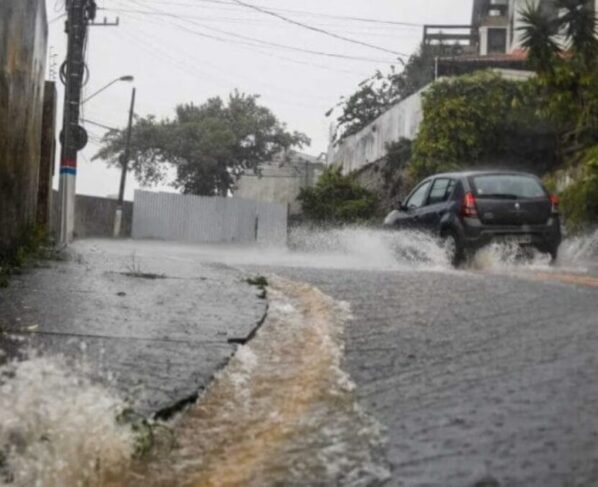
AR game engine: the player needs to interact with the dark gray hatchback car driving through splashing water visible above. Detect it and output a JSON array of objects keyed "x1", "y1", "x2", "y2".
[{"x1": 384, "y1": 171, "x2": 561, "y2": 264}]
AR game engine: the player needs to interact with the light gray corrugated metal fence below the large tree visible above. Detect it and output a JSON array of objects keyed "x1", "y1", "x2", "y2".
[{"x1": 132, "y1": 190, "x2": 287, "y2": 245}]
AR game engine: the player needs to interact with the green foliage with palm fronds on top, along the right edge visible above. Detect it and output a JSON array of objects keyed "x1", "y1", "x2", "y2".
[{"x1": 522, "y1": 0, "x2": 598, "y2": 231}]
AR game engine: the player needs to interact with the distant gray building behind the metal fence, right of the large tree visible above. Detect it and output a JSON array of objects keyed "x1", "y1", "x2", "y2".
[{"x1": 233, "y1": 150, "x2": 325, "y2": 215}]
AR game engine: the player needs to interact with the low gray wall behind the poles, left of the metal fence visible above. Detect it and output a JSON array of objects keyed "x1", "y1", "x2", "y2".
[{"x1": 52, "y1": 191, "x2": 133, "y2": 238}]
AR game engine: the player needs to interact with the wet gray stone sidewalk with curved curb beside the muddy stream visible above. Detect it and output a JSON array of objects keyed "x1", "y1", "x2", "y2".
[{"x1": 0, "y1": 240, "x2": 267, "y2": 415}]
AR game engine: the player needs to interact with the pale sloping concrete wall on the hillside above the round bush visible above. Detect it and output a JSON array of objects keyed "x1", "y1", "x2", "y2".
[{"x1": 327, "y1": 87, "x2": 427, "y2": 174}]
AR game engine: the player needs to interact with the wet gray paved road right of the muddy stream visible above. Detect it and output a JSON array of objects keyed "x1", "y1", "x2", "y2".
[{"x1": 247, "y1": 268, "x2": 598, "y2": 487}]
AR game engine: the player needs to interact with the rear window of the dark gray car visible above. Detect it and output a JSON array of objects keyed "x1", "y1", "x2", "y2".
[{"x1": 471, "y1": 174, "x2": 546, "y2": 199}]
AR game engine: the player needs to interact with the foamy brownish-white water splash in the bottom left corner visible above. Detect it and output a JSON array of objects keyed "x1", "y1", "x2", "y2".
[{"x1": 0, "y1": 357, "x2": 133, "y2": 487}]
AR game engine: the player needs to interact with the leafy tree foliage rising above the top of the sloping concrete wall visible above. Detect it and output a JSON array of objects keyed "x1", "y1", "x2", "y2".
[{"x1": 327, "y1": 44, "x2": 450, "y2": 142}]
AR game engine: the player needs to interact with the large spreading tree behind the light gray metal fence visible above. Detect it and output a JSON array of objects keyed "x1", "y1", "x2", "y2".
[{"x1": 94, "y1": 92, "x2": 310, "y2": 196}]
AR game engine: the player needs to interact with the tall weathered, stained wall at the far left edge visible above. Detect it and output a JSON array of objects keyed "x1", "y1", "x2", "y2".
[{"x1": 0, "y1": 0, "x2": 48, "y2": 252}]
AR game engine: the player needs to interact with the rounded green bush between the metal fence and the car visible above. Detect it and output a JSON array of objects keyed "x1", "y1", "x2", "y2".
[{"x1": 299, "y1": 168, "x2": 378, "y2": 224}]
